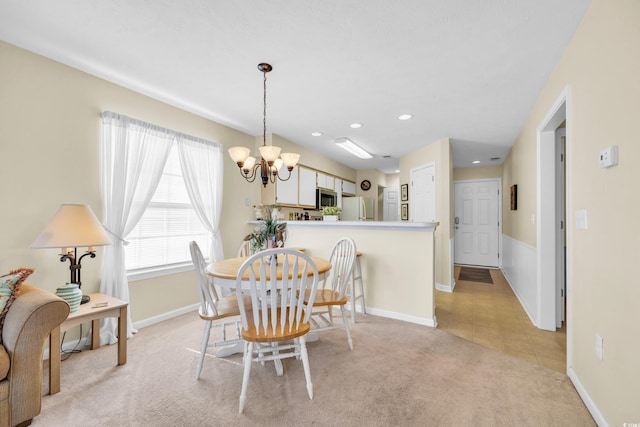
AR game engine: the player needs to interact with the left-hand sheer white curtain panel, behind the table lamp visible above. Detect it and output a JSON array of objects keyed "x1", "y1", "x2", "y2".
[{"x1": 100, "y1": 111, "x2": 175, "y2": 344}]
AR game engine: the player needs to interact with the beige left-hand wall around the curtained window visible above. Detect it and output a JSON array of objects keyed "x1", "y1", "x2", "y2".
[{"x1": 0, "y1": 42, "x2": 260, "y2": 322}]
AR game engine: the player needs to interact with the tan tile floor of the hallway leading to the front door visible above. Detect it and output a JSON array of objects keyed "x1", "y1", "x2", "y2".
[{"x1": 436, "y1": 266, "x2": 567, "y2": 373}]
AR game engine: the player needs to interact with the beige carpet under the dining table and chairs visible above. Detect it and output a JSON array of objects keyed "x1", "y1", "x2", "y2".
[{"x1": 32, "y1": 313, "x2": 595, "y2": 426}]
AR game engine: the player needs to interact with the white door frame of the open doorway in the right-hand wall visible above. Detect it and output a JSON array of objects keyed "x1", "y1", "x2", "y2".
[{"x1": 536, "y1": 86, "x2": 571, "y2": 336}]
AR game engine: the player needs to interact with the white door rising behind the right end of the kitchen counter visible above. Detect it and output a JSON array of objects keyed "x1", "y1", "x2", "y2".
[{"x1": 409, "y1": 163, "x2": 436, "y2": 222}]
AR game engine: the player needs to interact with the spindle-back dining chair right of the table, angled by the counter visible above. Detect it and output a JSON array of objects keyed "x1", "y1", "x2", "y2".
[{"x1": 305, "y1": 237, "x2": 356, "y2": 350}]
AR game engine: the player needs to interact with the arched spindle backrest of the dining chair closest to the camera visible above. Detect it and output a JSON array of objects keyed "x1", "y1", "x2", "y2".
[{"x1": 236, "y1": 248, "x2": 318, "y2": 336}]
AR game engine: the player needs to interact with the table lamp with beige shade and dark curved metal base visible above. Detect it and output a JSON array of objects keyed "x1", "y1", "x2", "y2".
[{"x1": 31, "y1": 204, "x2": 111, "y2": 304}]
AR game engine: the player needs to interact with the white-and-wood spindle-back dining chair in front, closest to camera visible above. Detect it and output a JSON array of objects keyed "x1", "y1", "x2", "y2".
[{"x1": 236, "y1": 248, "x2": 318, "y2": 413}]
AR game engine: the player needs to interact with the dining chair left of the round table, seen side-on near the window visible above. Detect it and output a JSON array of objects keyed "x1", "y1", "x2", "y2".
[{"x1": 189, "y1": 241, "x2": 248, "y2": 379}]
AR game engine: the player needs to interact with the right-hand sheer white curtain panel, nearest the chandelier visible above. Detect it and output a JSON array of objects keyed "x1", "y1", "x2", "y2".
[{"x1": 176, "y1": 134, "x2": 224, "y2": 261}]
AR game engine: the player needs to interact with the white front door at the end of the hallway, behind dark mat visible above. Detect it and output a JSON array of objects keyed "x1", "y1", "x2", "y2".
[{"x1": 454, "y1": 179, "x2": 500, "y2": 267}]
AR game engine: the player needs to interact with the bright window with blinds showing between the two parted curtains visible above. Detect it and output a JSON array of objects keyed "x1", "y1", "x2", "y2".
[{"x1": 125, "y1": 144, "x2": 209, "y2": 279}]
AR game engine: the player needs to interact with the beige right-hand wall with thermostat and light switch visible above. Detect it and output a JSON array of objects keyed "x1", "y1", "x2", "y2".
[{"x1": 503, "y1": 0, "x2": 640, "y2": 426}]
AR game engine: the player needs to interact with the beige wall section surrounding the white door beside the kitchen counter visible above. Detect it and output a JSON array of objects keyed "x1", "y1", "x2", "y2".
[{"x1": 399, "y1": 138, "x2": 453, "y2": 287}]
